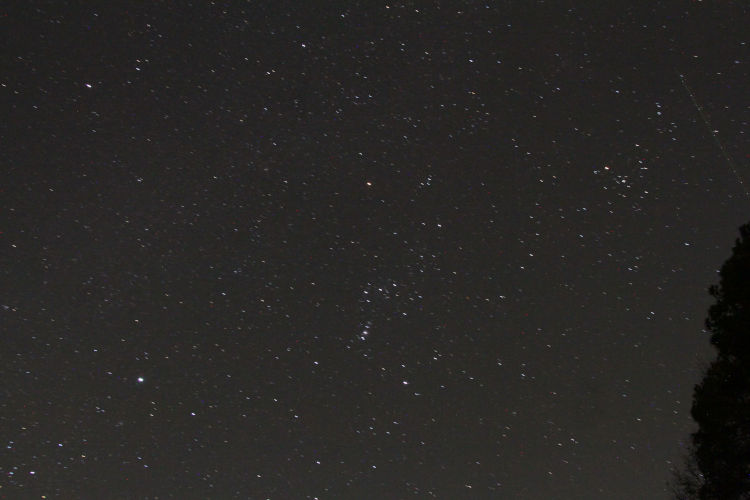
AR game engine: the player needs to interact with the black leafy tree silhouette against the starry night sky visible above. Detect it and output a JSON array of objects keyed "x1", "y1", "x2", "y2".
[{"x1": 674, "y1": 224, "x2": 750, "y2": 500}]
